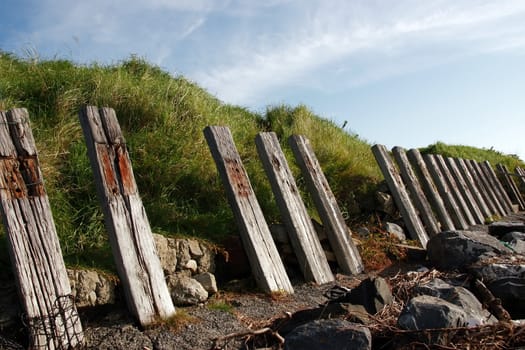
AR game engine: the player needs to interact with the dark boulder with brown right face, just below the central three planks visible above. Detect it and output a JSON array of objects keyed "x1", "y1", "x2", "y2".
[{"x1": 330, "y1": 277, "x2": 393, "y2": 315}]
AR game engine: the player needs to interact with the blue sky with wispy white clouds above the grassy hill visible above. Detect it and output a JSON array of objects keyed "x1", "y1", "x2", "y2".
[{"x1": 0, "y1": 0, "x2": 525, "y2": 159}]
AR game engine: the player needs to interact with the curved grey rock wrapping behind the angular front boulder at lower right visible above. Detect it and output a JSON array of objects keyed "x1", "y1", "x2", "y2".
[{"x1": 414, "y1": 278, "x2": 498, "y2": 326}]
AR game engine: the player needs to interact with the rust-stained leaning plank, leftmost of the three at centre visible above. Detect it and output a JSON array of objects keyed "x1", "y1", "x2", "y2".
[{"x1": 204, "y1": 126, "x2": 293, "y2": 293}]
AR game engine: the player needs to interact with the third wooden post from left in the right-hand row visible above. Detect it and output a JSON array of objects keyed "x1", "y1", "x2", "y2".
[{"x1": 407, "y1": 149, "x2": 456, "y2": 230}]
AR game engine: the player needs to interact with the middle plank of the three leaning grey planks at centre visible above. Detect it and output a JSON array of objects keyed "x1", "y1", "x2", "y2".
[{"x1": 255, "y1": 132, "x2": 334, "y2": 284}]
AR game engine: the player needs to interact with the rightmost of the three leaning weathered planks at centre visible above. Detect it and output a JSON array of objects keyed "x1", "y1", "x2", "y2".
[{"x1": 288, "y1": 135, "x2": 364, "y2": 274}]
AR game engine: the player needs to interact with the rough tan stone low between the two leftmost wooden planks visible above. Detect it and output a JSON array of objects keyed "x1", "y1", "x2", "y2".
[{"x1": 67, "y1": 269, "x2": 117, "y2": 307}]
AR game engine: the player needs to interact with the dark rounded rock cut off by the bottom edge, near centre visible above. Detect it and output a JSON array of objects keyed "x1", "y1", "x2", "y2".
[{"x1": 284, "y1": 319, "x2": 372, "y2": 350}]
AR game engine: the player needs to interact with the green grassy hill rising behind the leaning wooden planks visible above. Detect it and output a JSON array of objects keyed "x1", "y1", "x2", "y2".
[{"x1": 0, "y1": 51, "x2": 519, "y2": 263}]
